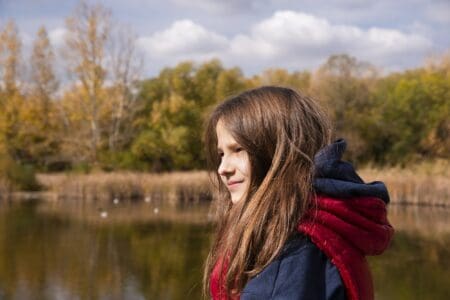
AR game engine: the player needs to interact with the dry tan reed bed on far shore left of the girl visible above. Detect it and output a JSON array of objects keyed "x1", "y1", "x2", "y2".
[{"x1": 38, "y1": 171, "x2": 211, "y2": 204}]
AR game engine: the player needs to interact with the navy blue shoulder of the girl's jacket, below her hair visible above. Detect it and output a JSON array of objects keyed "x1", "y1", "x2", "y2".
[{"x1": 241, "y1": 235, "x2": 345, "y2": 300}]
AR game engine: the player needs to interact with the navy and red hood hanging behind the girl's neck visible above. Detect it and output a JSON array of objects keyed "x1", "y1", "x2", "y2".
[{"x1": 298, "y1": 139, "x2": 394, "y2": 300}]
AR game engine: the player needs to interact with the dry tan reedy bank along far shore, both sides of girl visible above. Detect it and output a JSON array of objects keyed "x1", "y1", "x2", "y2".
[{"x1": 1, "y1": 160, "x2": 450, "y2": 206}]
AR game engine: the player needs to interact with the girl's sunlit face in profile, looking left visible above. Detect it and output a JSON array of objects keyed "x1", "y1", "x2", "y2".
[{"x1": 216, "y1": 120, "x2": 251, "y2": 204}]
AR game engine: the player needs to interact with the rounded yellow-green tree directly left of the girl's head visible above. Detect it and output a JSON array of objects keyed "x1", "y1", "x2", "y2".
[{"x1": 131, "y1": 60, "x2": 251, "y2": 171}]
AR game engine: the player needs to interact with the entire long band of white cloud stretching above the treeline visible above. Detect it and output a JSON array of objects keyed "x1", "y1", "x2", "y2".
[{"x1": 138, "y1": 11, "x2": 433, "y2": 73}]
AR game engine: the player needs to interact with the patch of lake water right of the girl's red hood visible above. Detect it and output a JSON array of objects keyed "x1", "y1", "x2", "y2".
[{"x1": 369, "y1": 206, "x2": 450, "y2": 300}]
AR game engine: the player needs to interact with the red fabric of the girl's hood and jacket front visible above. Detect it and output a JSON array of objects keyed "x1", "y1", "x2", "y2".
[{"x1": 210, "y1": 195, "x2": 394, "y2": 300}]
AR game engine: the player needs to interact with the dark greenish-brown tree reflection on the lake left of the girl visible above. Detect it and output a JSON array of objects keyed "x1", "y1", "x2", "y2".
[{"x1": 0, "y1": 202, "x2": 211, "y2": 299}]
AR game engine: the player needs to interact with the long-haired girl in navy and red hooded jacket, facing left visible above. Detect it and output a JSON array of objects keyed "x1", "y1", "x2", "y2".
[{"x1": 204, "y1": 86, "x2": 393, "y2": 300}]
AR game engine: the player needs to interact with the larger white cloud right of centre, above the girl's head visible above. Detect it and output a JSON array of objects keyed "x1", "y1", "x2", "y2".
[{"x1": 227, "y1": 11, "x2": 432, "y2": 68}]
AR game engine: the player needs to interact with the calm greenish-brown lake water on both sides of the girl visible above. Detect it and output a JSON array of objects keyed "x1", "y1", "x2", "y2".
[{"x1": 0, "y1": 200, "x2": 450, "y2": 299}]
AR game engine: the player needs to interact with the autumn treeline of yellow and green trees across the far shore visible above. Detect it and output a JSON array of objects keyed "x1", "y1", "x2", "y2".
[{"x1": 0, "y1": 2, "x2": 450, "y2": 188}]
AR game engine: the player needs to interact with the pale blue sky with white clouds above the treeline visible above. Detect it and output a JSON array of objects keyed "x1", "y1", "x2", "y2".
[{"x1": 0, "y1": 0, "x2": 450, "y2": 76}]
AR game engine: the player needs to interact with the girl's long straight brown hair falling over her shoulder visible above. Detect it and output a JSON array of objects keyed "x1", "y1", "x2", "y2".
[{"x1": 203, "y1": 86, "x2": 330, "y2": 296}]
